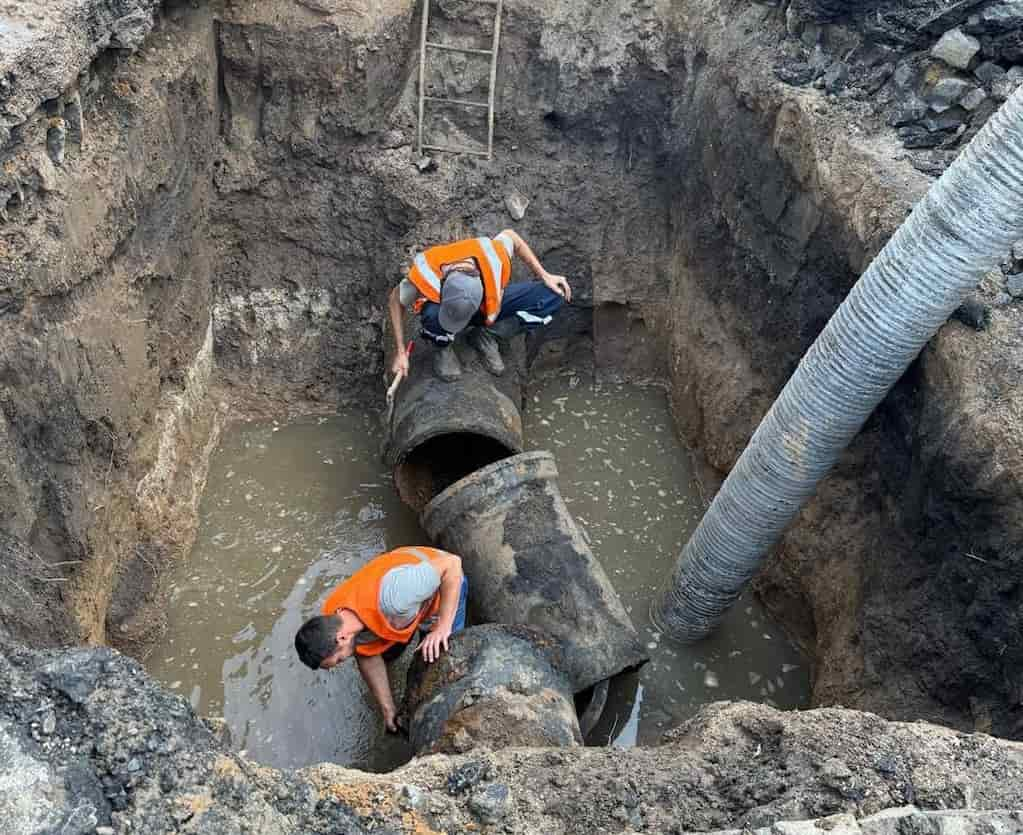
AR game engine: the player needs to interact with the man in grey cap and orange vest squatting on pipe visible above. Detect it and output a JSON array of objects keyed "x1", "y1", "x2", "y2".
[{"x1": 388, "y1": 229, "x2": 572, "y2": 382}]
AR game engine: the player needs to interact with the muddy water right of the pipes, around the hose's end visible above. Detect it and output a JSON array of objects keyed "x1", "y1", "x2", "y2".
[{"x1": 524, "y1": 375, "x2": 809, "y2": 746}]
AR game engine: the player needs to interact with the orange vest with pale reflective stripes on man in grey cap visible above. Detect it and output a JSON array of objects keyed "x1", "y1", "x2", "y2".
[{"x1": 408, "y1": 237, "x2": 512, "y2": 324}]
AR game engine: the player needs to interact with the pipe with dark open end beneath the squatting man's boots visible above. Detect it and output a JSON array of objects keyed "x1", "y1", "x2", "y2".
[{"x1": 384, "y1": 337, "x2": 525, "y2": 511}]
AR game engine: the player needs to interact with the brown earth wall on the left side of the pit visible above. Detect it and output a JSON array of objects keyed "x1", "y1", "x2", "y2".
[{"x1": 0, "y1": 3, "x2": 216, "y2": 645}]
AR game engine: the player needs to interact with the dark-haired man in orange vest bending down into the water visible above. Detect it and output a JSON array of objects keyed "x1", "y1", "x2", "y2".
[{"x1": 295, "y1": 547, "x2": 466, "y2": 733}]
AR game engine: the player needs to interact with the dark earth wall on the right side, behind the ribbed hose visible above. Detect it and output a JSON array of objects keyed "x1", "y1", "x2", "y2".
[{"x1": 671, "y1": 3, "x2": 1023, "y2": 736}]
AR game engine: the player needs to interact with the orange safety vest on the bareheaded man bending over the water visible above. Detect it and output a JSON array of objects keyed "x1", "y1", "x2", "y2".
[{"x1": 321, "y1": 547, "x2": 444, "y2": 655}]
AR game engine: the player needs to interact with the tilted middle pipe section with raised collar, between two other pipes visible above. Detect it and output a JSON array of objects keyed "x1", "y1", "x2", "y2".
[{"x1": 420, "y1": 452, "x2": 648, "y2": 693}]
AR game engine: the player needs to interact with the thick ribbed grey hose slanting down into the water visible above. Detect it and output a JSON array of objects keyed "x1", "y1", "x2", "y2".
[{"x1": 652, "y1": 89, "x2": 1023, "y2": 642}]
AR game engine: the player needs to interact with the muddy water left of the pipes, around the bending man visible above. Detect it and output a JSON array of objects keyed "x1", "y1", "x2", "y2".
[{"x1": 146, "y1": 413, "x2": 424, "y2": 770}]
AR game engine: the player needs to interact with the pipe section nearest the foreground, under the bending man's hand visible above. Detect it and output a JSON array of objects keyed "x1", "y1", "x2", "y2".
[{"x1": 402, "y1": 624, "x2": 582, "y2": 754}]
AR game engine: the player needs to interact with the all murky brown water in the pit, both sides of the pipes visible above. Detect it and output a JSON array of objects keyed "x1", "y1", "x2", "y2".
[{"x1": 147, "y1": 377, "x2": 807, "y2": 770}]
